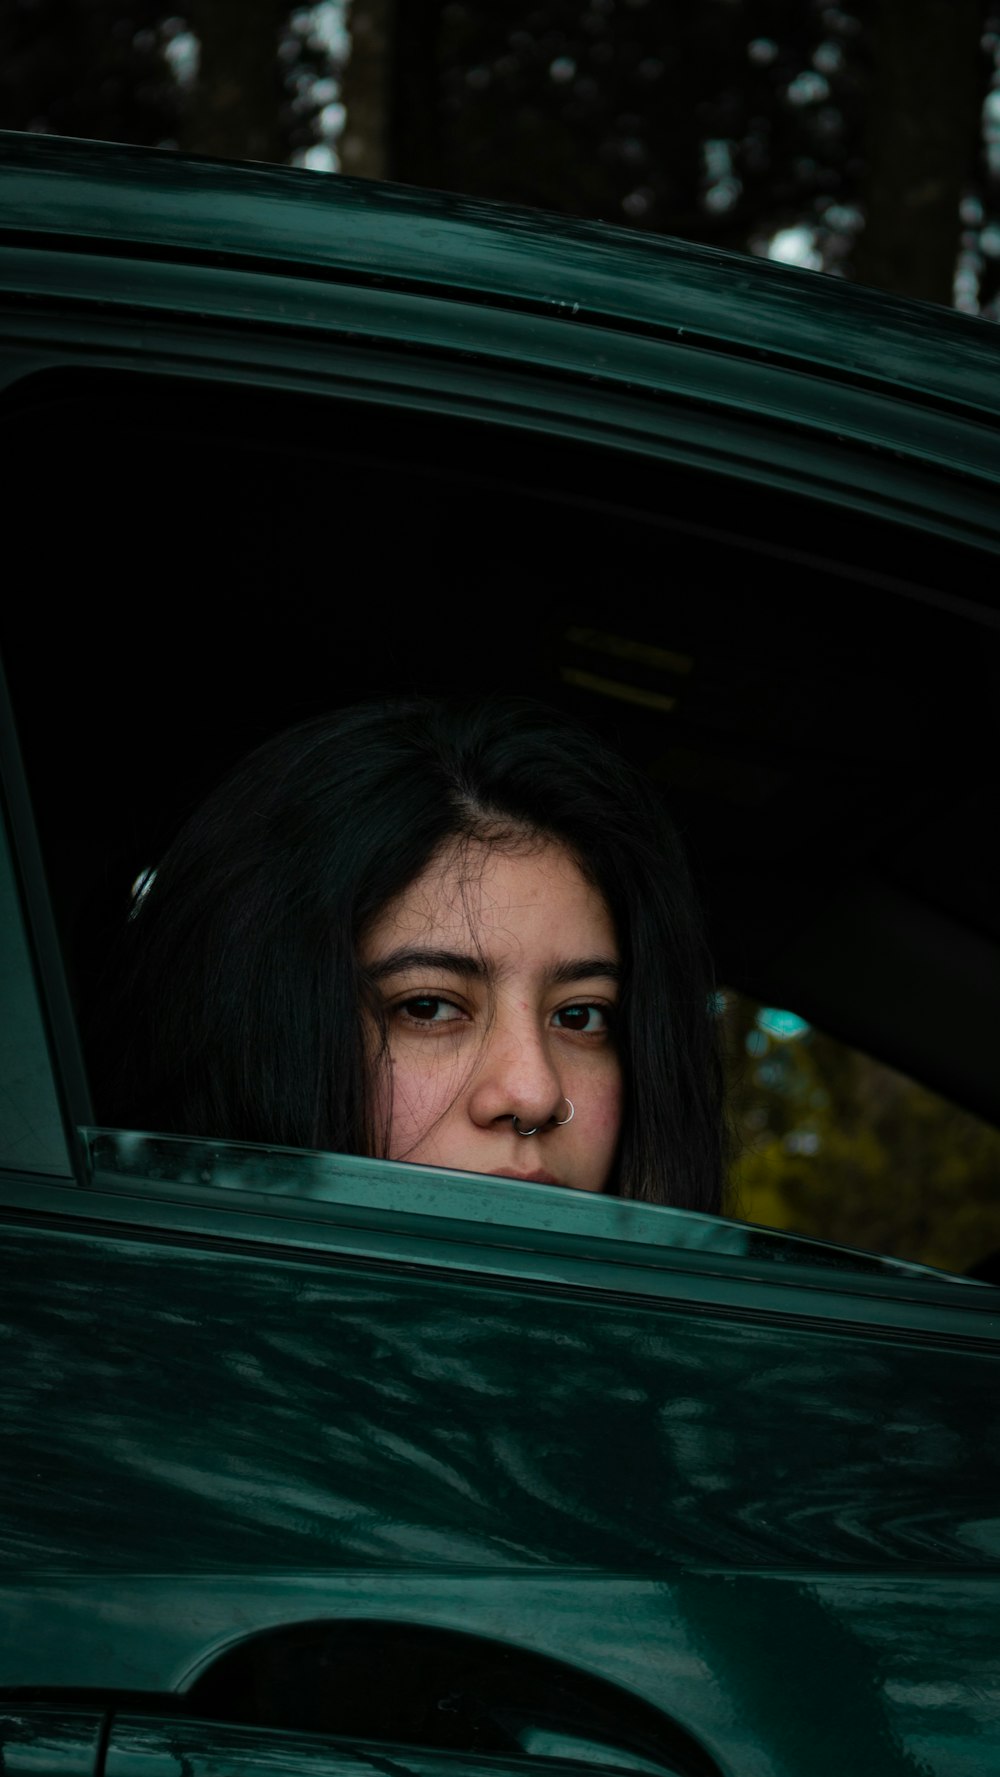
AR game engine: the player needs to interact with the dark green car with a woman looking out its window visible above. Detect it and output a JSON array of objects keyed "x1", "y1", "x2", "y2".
[{"x1": 0, "y1": 137, "x2": 1000, "y2": 1777}]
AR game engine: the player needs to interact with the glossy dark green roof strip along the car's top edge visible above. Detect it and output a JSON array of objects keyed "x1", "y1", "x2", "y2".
[{"x1": 0, "y1": 131, "x2": 1000, "y2": 430}]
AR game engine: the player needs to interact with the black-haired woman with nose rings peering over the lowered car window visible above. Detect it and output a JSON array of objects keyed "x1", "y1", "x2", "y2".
[{"x1": 101, "y1": 700, "x2": 721, "y2": 1210}]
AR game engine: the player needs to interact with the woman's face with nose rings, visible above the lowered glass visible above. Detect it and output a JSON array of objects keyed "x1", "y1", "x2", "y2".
[{"x1": 361, "y1": 841, "x2": 622, "y2": 1191}]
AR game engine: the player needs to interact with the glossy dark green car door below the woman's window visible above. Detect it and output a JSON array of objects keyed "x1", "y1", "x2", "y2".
[{"x1": 0, "y1": 657, "x2": 998, "y2": 1772}]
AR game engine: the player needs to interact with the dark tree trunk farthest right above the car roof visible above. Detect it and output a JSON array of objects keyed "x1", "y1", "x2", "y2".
[{"x1": 854, "y1": 0, "x2": 982, "y2": 304}]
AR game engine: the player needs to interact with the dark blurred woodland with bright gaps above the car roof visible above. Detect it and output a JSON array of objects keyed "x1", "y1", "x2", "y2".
[{"x1": 0, "y1": 0, "x2": 1000, "y2": 316}]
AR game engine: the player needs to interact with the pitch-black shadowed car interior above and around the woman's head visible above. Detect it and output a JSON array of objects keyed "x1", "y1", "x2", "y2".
[{"x1": 2, "y1": 370, "x2": 1000, "y2": 1265}]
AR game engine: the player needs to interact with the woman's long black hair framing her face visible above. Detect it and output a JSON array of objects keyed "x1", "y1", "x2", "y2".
[{"x1": 99, "y1": 698, "x2": 723, "y2": 1210}]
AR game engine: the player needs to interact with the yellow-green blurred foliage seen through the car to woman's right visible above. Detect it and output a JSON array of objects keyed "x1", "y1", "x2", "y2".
[{"x1": 725, "y1": 993, "x2": 1000, "y2": 1272}]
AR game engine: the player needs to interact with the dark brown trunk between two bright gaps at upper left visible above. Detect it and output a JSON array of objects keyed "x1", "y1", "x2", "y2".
[{"x1": 179, "y1": 0, "x2": 286, "y2": 162}]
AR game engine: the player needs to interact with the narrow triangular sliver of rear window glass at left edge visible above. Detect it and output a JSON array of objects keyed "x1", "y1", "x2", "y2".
[{"x1": 0, "y1": 821, "x2": 71, "y2": 1178}]
